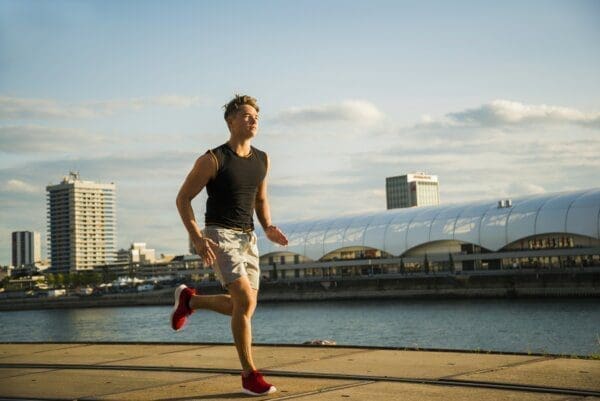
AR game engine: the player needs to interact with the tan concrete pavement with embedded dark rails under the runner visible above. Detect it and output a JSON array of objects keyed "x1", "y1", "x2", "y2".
[{"x1": 0, "y1": 343, "x2": 600, "y2": 401}]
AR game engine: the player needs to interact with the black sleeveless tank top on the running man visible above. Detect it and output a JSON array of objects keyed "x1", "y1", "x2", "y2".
[{"x1": 204, "y1": 143, "x2": 267, "y2": 231}]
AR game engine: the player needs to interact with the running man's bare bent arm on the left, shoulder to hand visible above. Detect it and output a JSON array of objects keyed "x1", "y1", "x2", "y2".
[{"x1": 176, "y1": 153, "x2": 217, "y2": 265}]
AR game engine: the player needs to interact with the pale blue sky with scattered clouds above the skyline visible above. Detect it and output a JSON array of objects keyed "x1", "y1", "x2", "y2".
[{"x1": 0, "y1": 0, "x2": 600, "y2": 264}]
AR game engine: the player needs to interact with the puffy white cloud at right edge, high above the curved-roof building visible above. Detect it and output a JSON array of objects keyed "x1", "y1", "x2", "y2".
[{"x1": 446, "y1": 100, "x2": 600, "y2": 129}]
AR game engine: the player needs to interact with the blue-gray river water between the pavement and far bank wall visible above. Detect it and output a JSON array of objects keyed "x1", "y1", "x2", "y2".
[{"x1": 0, "y1": 298, "x2": 600, "y2": 355}]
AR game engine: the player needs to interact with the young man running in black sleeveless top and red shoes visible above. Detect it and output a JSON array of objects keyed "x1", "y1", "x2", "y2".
[{"x1": 171, "y1": 95, "x2": 288, "y2": 395}]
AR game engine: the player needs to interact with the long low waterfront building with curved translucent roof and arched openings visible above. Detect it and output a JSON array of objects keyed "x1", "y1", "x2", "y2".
[{"x1": 257, "y1": 189, "x2": 600, "y2": 276}]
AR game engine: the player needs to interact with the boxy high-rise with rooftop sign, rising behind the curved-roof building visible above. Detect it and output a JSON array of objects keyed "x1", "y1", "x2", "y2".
[{"x1": 385, "y1": 173, "x2": 440, "y2": 209}]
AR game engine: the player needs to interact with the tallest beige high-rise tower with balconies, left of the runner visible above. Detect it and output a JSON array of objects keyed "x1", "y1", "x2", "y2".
[{"x1": 46, "y1": 172, "x2": 117, "y2": 271}]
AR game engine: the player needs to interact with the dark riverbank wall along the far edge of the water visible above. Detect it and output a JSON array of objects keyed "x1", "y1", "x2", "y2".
[{"x1": 0, "y1": 268, "x2": 600, "y2": 311}]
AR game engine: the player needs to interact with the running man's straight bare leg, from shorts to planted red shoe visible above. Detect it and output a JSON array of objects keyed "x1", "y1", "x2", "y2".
[{"x1": 227, "y1": 276, "x2": 258, "y2": 374}]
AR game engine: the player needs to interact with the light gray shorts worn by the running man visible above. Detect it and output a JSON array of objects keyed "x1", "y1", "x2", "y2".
[{"x1": 202, "y1": 226, "x2": 260, "y2": 290}]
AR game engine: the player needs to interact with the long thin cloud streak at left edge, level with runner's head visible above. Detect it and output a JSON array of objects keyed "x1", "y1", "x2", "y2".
[{"x1": 0, "y1": 95, "x2": 201, "y2": 120}]
